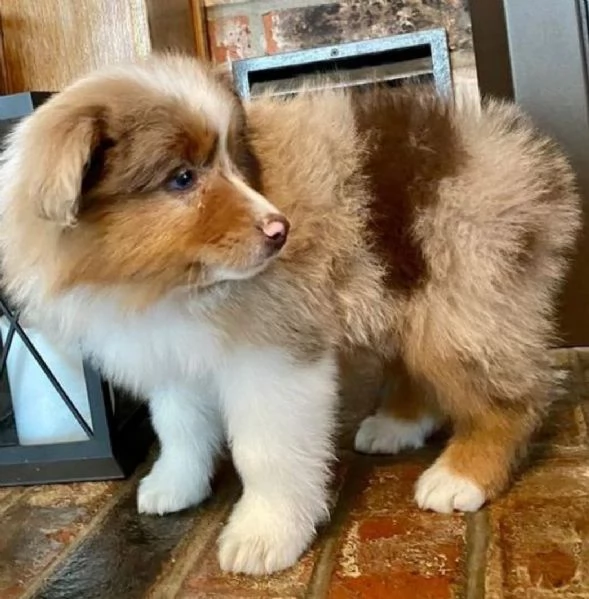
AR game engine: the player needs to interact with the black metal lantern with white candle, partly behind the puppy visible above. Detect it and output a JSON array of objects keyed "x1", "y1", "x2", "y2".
[{"x1": 0, "y1": 93, "x2": 154, "y2": 486}]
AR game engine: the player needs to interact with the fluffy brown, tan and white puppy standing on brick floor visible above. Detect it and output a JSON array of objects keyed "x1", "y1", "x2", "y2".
[{"x1": 0, "y1": 56, "x2": 580, "y2": 574}]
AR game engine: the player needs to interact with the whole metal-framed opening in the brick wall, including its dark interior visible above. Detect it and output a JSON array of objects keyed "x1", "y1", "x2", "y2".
[{"x1": 232, "y1": 29, "x2": 452, "y2": 98}]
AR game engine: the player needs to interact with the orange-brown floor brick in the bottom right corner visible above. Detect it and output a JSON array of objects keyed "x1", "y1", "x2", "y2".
[{"x1": 486, "y1": 454, "x2": 589, "y2": 599}]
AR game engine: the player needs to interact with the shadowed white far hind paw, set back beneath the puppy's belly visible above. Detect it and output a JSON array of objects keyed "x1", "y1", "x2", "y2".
[{"x1": 354, "y1": 413, "x2": 437, "y2": 454}]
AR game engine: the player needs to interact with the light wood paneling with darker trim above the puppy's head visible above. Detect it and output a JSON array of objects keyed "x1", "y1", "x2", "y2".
[{"x1": 0, "y1": 0, "x2": 206, "y2": 94}]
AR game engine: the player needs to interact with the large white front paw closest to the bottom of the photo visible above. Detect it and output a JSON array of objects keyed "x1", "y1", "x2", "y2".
[{"x1": 219, "y1": 497, "x2": 315, "y2": 575}]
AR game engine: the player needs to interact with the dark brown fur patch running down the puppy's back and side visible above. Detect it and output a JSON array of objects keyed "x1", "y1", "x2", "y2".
[{"x1": 352, "y1": 88, "x2": 465, "y2": 292}]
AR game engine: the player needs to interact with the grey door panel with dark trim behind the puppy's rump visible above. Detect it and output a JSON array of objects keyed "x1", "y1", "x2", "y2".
[{"x1": 469, "y1": 0, "x2": 589, "y2": 346}]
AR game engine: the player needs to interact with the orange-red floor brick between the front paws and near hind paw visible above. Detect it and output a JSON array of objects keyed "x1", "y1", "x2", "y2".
[{"x1": 328, "y1": 456, "x2": 466, "y2": 599}]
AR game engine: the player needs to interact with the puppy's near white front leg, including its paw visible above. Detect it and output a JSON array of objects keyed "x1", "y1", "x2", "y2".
[{"x1": 219, "y1": 348, "x2": 337, "y2": 574}]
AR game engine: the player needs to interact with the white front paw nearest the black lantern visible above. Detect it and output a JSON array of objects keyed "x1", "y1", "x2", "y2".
[{"x1": 137, "y1": 463, "x2": 211, "y2": 516}]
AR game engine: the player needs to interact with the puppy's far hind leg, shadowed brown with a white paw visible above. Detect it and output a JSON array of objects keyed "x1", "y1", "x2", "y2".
[{"x1": 354, "y1": 359, "x2": 442, "y2": 454}]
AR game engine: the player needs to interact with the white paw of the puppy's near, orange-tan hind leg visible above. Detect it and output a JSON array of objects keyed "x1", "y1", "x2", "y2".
[{"x1": 415, "y1": 462, "x2": 486, "y2": 514}]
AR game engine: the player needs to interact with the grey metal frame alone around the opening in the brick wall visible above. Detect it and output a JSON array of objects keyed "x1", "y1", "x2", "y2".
[{"x1": 232, "y1": 29, "x2": 452, "y2": 99}]
